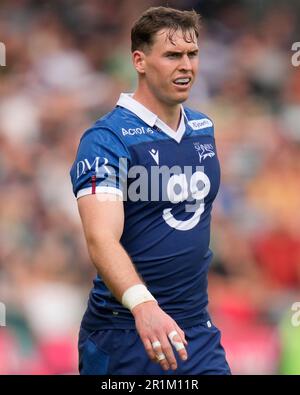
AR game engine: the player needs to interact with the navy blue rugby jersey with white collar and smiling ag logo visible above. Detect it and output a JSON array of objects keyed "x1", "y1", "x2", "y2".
[{"x1": 70, "y1": 94, "x2": 220, "y2": 329}]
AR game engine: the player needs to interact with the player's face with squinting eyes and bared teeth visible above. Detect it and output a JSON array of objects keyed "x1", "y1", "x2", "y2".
[{"x1": 138, "y1": 29, "x2": 199, "y2": 105}]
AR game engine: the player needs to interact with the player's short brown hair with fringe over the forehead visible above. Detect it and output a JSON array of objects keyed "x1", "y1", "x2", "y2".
[{"x1": 131, "y1": 7, "x2": 200, "y2": 52}]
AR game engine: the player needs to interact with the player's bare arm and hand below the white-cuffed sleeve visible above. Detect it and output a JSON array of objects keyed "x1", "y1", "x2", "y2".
[{"x1": 78, "y1": 194, "x2": 187, "y2": 370}]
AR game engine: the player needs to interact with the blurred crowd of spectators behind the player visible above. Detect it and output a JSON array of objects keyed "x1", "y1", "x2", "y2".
[{"x1": 0, "y1": 0, "x2": 300, "y2": 374}]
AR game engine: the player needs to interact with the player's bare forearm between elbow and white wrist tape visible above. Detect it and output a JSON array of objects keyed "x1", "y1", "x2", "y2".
[{"x1": 88, "y1": 234, "x2": 143, "y2": 302}]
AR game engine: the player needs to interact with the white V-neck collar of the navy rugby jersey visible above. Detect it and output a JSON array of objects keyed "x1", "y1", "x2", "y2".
[{"x1": 117, "y1": 93, "x2": 186, "y2": 143}]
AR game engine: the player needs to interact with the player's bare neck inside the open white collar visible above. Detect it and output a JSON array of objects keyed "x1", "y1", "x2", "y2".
[{"x1": 133, "y1": 90, "x2": 181, "y2": 132}]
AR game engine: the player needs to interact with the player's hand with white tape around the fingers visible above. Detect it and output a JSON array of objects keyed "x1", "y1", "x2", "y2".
[{"x1": 132, "y1": 301, "x2": 188, "y2": 370}]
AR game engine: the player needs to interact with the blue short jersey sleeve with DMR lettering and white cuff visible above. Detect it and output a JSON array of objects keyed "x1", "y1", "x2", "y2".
[{"x1": 70, "y1": 127, "x2": 130, "y2": 199}]
